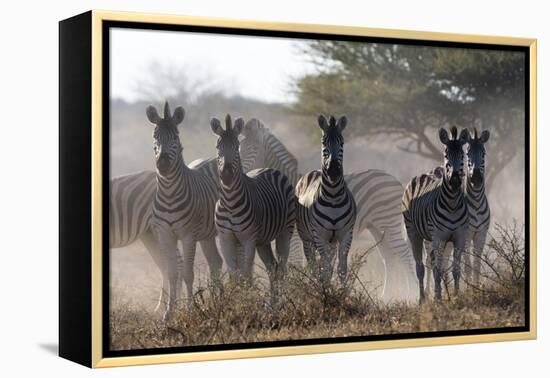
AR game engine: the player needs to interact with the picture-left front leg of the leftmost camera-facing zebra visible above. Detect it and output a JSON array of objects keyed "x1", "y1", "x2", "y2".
[{"x1": 155, "y1": 227, "x2": 181, "y2": 321}]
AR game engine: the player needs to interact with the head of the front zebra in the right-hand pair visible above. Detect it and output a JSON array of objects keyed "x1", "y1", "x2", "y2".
[{"x1": 439, "y1": 126, "x2": 469, "y2": 190}]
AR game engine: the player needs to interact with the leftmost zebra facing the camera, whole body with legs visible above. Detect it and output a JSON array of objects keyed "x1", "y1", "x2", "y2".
[{"x1": 146, "y1": 102, "x2": 222, "y2": 320}]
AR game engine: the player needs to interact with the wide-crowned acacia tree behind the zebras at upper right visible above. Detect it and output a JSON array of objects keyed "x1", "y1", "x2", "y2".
[{"x1": 294, "y1": 41, "x2": 525, "y2": 187}]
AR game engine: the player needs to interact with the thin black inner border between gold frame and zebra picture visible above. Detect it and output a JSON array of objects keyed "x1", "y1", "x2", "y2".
[{"x1": 101, "y1": 20, "x2": 532, "y2": 358}]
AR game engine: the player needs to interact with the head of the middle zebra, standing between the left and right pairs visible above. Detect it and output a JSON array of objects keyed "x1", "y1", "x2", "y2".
[{"x1": 318, "y1": 114, "x2": 348, "y2": 182}]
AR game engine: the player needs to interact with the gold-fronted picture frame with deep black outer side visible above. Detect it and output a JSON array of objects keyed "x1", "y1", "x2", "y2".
[{"x1": 60, "y1": 10, "x2": 537, "y2": 367}]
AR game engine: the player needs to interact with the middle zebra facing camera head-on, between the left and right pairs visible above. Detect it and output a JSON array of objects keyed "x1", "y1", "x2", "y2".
[{"x1": 296, "y1": 115, "x2": 357, "y2": 286}]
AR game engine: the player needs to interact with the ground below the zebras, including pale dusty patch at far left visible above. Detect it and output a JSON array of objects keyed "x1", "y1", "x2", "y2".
[{"x1": 110, "y1": 224, "x2": 525, "y2": 350}]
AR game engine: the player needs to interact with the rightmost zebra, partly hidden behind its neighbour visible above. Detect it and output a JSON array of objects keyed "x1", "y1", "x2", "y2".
[{"x1": 465, "y1": 128, "x2": 491, "y2": 286}]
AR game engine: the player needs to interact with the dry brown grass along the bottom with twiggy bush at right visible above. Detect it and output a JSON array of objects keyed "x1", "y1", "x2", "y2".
[{"x1": 110, "y1": 223, "x2": 525, "y2": 350}]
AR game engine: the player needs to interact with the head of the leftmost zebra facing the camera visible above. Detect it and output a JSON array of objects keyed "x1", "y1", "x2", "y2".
[{"x1": 146, "y1": 101, "x2": 185, "y2": 176}]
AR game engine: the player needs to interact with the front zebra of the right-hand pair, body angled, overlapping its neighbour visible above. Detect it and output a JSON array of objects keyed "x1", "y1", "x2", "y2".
[{"x1": 402, "y1": 126, "x2": 469, "y2": 303}]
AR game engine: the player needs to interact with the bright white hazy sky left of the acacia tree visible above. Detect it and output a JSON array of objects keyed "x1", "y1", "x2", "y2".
[{"x1": 111, "y1": 29, "x2": 320, "y2": 102}]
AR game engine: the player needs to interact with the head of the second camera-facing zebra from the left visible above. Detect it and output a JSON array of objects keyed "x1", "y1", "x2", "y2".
[{"x1": 210, "y1": 114, "x2": 244, "y2": 187}]
